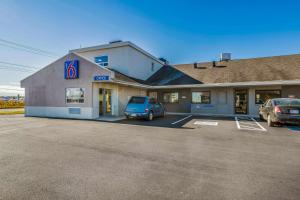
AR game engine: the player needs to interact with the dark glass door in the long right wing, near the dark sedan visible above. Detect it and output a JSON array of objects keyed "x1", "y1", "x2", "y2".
[{"x1": 234, "y1": 89, "x2": 248, "y2": 114}]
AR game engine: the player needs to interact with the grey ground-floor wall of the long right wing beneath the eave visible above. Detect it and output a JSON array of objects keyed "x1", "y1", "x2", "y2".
[{"x1": 149, "y1": 86, "x2": 292, "y2": 116}]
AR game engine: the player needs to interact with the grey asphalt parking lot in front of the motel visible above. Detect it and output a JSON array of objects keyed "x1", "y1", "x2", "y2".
[{"x1": 0, "y1": 115, "x2": 300, "y2": 200}]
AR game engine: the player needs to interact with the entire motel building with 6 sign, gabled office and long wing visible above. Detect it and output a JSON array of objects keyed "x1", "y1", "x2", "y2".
[{"x1": 21, "y1": 41, "x2": 300, "y2": 119}]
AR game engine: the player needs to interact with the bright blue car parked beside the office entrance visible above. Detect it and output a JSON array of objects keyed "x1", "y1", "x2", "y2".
[{"x1": 124, "y1": 96, "x2": 165, "y2": 121}]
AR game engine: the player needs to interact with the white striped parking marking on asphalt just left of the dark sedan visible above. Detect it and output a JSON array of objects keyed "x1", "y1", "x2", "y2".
[{"x1": 235, "y1": 117, "x2": 267, "y2": 131}]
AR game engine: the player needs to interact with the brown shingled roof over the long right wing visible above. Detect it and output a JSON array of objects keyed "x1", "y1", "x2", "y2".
[{"x1": 173, "y1": 54, "x2": 300, "y2": 83}]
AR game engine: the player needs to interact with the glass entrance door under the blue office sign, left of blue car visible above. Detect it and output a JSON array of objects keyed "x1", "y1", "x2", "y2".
[{"x1": 99, "y1": 88, "x2": 112, "y2": 115}]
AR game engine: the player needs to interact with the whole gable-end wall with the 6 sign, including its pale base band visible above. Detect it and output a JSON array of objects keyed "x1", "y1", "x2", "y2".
[{"x1": 21, "y1": 53, "x2": 113, "y2": 118}]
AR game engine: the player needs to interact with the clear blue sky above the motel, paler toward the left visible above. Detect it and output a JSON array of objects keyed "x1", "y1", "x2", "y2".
[{"x1": 0, "y1": 0, "x2": 300, "y2": 96}]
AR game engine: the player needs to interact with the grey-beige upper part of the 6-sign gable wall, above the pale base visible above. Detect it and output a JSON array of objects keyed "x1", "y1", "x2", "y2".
[{"x1": 21, "y1": 54, "x2": 110, "y2": 107}]
